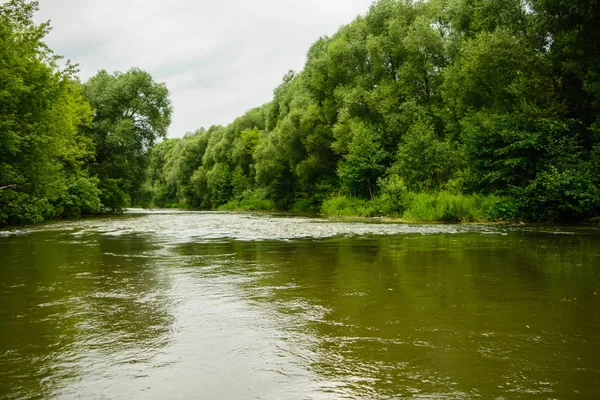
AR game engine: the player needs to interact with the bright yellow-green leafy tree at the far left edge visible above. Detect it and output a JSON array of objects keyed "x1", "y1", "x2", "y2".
[{"x1": 0, "y1": 0, "x2": 97, "y2": 224}]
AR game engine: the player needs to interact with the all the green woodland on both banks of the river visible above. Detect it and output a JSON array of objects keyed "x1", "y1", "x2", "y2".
[{"x1": 0, "y1": 0, "x2": 600, "y2": 224}]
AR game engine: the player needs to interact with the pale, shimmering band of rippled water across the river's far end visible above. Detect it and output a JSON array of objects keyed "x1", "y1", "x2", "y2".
[{"x1": 1, "y1": 210, "x2": 512, "y2": 244}]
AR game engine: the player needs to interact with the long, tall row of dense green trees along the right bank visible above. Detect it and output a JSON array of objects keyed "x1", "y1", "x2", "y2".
[{"x1": 145, "y1": 0, "x2": 600, "y2": 220}]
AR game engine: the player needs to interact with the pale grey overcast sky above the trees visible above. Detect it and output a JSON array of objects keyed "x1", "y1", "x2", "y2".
[{"x1": 31, "y1": 0, "x2": 371, "y2": 137}]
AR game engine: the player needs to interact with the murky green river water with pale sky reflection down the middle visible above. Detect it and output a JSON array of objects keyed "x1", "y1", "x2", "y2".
[{"x1": 0, "y1": 211, "x2": 600, "y2": 399}]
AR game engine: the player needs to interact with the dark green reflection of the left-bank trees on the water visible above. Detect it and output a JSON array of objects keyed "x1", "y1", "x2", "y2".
[{"x1": 0, "y1": 233, "x2": 173, "y2": 398}]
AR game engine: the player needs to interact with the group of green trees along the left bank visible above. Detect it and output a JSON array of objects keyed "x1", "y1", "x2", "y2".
[{"x1": 0, "y1": 0, "x2": 171, "y2": 225}]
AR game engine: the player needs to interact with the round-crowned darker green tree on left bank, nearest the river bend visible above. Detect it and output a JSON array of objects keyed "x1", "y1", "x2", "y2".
[{"x1": 84, "y1": 68, "x2": 173, "y2": 210}]
